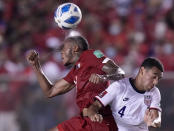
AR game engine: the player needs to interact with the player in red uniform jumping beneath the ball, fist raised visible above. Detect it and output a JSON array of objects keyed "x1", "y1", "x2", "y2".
[{"x1": 27, "y1": 36, "x2": 124, "y2": 131}]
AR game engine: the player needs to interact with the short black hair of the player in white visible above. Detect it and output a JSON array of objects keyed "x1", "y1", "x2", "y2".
[{"x1": 141, "y1": 57, "x2": 164, "y2": 72}]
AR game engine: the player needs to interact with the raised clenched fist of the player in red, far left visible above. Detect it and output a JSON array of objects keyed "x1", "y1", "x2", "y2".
[{"x1": 26, "y1": 50, "x2": 39, "y2": 66}]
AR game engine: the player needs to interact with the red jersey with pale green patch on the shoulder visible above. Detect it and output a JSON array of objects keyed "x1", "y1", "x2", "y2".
[{"x1": 64, "y1": 50, "x2": 111, "y2": 115}]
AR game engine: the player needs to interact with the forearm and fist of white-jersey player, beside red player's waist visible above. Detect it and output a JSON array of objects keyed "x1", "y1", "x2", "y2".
[{"x1": 83, "y1": 100, "x2": 103, "y2": 122}]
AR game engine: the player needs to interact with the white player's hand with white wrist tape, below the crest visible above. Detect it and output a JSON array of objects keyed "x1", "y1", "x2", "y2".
[{"x1": 144, "y1": 109, "x2": 161, "y2": 127}]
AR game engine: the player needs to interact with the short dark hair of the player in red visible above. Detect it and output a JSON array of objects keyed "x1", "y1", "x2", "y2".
[{"x1": 65, "y1": 36, "x2": 89, "y2": 51}]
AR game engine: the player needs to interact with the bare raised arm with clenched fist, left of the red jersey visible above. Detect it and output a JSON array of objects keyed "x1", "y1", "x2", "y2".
[{"x1": 26, "y1": 50, "x2": 74, "y2": 97}]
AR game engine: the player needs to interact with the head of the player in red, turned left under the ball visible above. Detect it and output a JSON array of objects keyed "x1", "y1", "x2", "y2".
[{"x1": 61, "y1": 36, "x2": 89, "y2": 66}]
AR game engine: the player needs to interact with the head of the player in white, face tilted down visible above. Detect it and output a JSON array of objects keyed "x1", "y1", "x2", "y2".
[{"x1": 139, "y1": 57, "x2": 164, "y2": 91}]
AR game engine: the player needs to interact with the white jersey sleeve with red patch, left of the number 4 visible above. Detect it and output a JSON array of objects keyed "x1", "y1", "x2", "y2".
[{"x1": 95, "y1": 82, "x2": 120, "y2": 106}]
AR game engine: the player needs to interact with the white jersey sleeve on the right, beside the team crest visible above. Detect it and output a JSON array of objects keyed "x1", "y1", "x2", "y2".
[{"x1": 150, "y1": 87, "x2": 161, "y2": 111}]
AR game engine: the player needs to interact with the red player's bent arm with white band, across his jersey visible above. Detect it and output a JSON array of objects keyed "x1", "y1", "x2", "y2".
[{"x1": 89, "y1": 59, "x2": 125, "y2": 84}]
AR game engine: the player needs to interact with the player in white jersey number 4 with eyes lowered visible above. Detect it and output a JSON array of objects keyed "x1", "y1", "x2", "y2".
[{"x1": 83, "y1": 58, "x2": 164, "y2": 131}]
